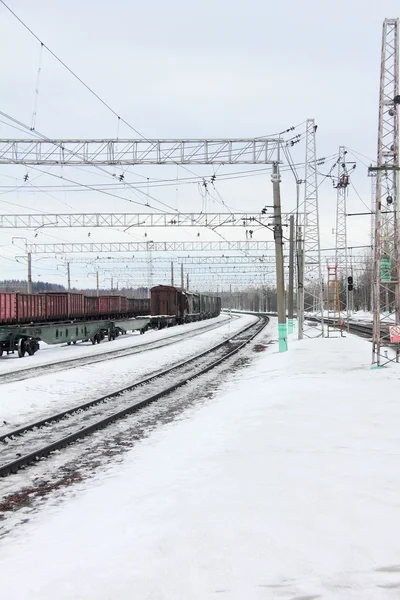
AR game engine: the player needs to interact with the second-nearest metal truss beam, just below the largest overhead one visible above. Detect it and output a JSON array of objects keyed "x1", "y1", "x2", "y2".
[{"x1": 0, "y1": 213, "x2": 272, "y2": 229}]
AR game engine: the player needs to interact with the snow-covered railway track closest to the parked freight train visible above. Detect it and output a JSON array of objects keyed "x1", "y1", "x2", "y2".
[{"x1": 0, "y1": 316, "x2": 234, "y2": 384}]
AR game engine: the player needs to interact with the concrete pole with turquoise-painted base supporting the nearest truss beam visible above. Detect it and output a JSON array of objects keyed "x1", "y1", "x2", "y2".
[{"x1": 271, "y1": 163, "x2": 288, "y2": 352}]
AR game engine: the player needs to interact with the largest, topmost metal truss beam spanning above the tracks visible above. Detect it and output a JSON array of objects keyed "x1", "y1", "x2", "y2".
[{"x1": 0, "y1": 138, "x2": 280, "y2": 165}]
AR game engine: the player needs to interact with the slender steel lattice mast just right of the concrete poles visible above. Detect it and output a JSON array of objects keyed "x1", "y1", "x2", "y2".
[{"x1": 303, "y1": 119, "x2": 324, "y2": 336}]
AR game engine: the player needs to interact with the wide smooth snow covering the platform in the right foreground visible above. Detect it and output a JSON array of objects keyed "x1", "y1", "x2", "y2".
[{"x1": 0, "y1": 326, "x2": 400, "y2": 600}]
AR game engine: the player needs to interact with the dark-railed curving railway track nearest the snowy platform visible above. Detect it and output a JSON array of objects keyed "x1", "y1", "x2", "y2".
[{"x1": 0, "y1": 318, "x2": 268, "y2": 477}]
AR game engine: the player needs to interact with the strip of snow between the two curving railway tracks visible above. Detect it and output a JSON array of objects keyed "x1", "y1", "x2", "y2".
[{"x1": 0, "y1": 315, "x2": 256, "y2": 426}]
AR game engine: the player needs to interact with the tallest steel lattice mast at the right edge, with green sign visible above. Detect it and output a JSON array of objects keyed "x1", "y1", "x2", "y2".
[{"x1": 370, "y1": 19, "x2": 400, "y2": 367}]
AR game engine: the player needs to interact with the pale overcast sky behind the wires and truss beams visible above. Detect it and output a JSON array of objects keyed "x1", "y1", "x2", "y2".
[{"x1": 0, "y1": 0, "x2": 400, "y2": 285}]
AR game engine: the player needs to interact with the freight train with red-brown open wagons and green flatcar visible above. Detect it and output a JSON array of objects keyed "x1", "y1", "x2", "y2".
[{"x1": 0, "y1": 285, "x2": 221, "y2": 357}]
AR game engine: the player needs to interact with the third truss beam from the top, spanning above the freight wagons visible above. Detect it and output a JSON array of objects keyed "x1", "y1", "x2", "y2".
[{"x1": 25, "y1": 240, "x2": 273, "y2": 254}]
